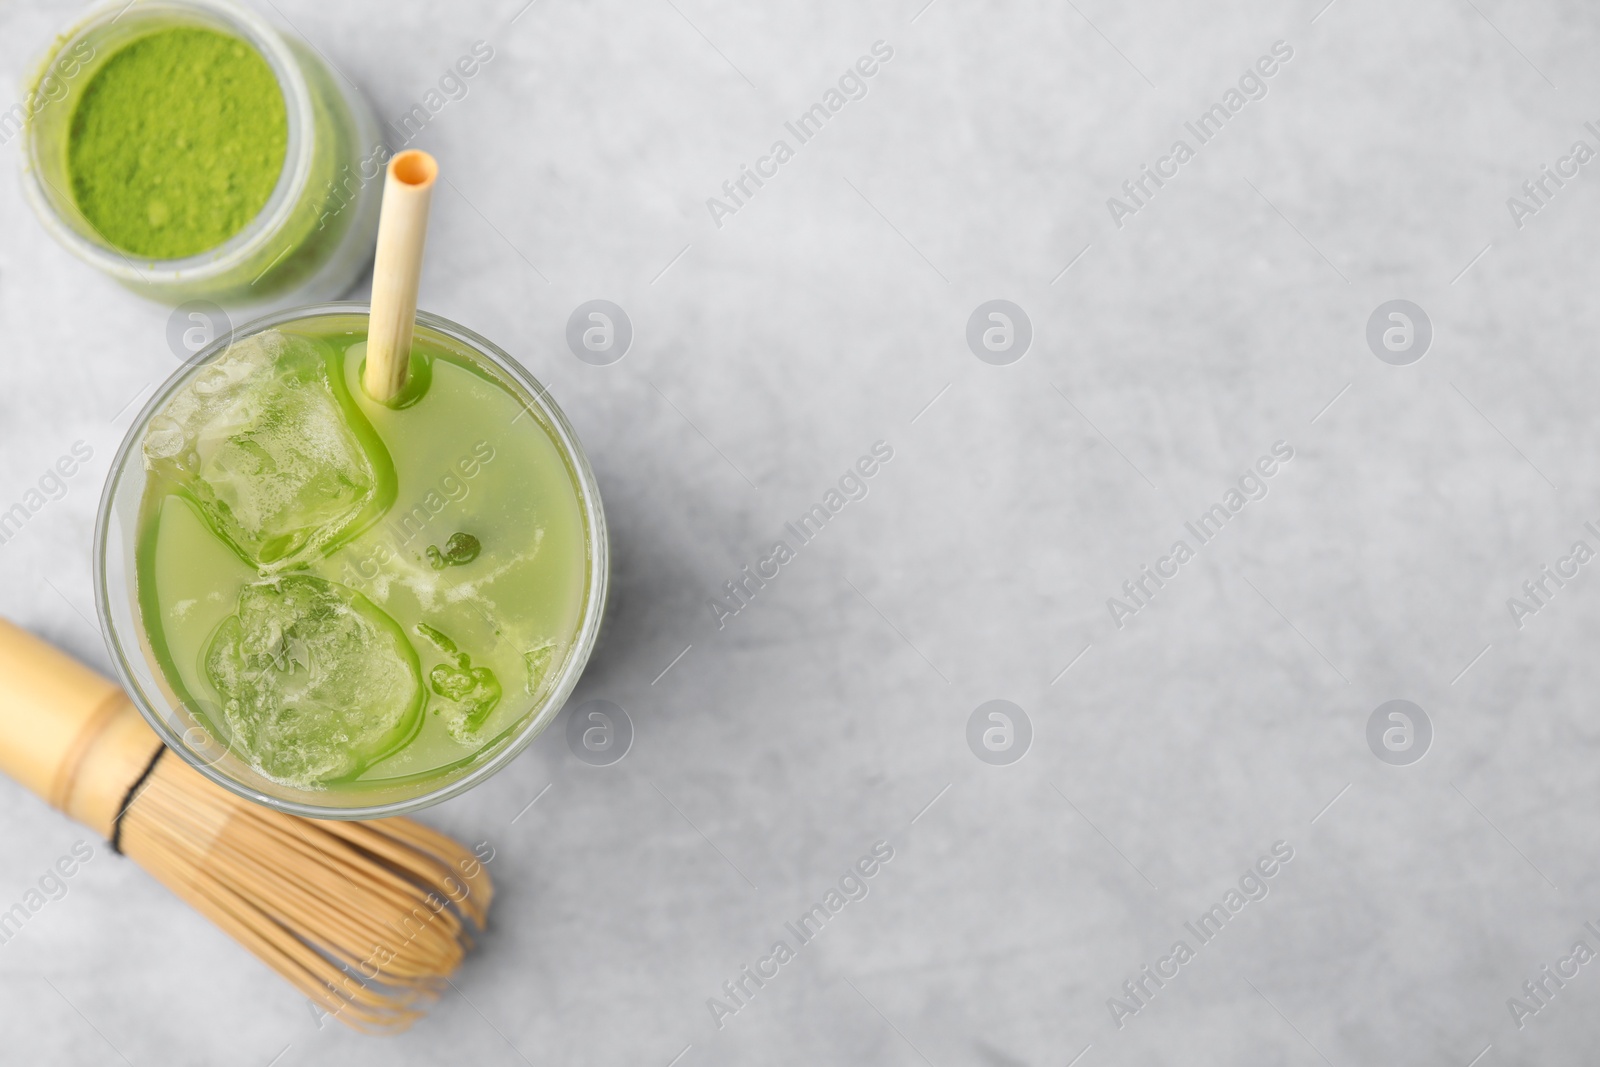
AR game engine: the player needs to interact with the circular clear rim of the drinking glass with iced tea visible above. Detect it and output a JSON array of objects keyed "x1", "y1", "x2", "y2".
[{"x1": 93, "y1": 301, "x2": 610, "y2": 819}]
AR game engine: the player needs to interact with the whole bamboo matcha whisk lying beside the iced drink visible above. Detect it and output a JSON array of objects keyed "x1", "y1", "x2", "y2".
[{"x1": 0, "y1": 619, "x2": 494, "y2": 1032}]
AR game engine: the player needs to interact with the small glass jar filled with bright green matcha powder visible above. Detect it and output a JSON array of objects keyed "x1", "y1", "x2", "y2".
[{"x1": 21, "y1": 0, "x2": 387, "y2": 307}]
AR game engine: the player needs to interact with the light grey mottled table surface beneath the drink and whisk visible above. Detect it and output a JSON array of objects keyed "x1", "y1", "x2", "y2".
[{"x1": 0, "y1": 0, "x2": 1600, "y2": 1067}]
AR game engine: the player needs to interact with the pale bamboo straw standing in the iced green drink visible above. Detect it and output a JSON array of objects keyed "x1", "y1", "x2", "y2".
[{"x1": 362, "y1": 149, "x2": 438, "y2": 403}]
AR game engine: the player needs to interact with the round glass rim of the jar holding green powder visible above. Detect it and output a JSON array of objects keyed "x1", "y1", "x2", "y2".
[{"x1": 21, "y1": 0, "x2": 315, "y2": 285}]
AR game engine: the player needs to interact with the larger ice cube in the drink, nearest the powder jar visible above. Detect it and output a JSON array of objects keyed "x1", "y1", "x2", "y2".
[{"x1": 144, "y1": 330, "x2": 394, "y2": 574}]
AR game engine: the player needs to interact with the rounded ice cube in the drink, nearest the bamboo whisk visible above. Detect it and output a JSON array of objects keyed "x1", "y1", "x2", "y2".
[{"x1": 205, "y1": 574, "x2": 424, "y2": 787}]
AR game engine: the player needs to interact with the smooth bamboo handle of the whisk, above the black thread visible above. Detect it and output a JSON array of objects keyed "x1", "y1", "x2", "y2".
[{"x1": 0, "y1": 619, "x2": 162, "y2": 837}]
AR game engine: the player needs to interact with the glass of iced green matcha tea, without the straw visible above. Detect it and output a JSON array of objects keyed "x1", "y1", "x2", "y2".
[{"x1": 96, "y1": 304, "x2": 606, "y2": 817}]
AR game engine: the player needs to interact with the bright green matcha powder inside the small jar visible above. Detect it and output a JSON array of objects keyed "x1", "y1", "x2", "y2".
[{"x1": 67, "y1": 27, "x2": 288, "y2": 259}]
